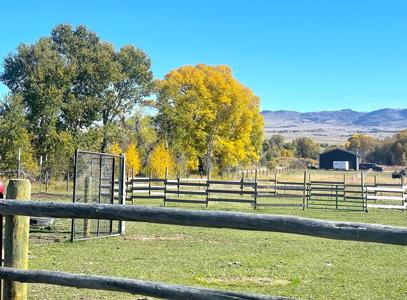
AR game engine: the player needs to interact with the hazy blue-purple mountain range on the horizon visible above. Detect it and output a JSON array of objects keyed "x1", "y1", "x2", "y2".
[{"x1": 261, "y1": 108, "x2": 407, "y2": 143}]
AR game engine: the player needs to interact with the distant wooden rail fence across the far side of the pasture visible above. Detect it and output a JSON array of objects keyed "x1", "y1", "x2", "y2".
[{"x1": 126, "y1": 172, "x2": 407, "y2": 211}]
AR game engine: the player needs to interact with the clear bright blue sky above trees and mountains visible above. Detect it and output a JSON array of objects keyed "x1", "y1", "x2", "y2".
[{"x1": 0, "y1": 0, "x2": 407, "y2": 111}]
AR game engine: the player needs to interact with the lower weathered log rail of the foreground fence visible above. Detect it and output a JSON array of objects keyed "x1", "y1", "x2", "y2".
[{"x1": 0, "y1": 267, "x2": 289, "y2": 300}]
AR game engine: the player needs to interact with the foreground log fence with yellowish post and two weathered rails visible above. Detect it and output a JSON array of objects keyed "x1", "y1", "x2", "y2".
[{"x1": 0, "y1": 179, "x2": 407, "y2": 300}]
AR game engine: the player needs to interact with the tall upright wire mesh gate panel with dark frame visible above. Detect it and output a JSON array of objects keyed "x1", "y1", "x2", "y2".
[{"x1": 71, "y1": 150, "x2": 124, "y2": 241}]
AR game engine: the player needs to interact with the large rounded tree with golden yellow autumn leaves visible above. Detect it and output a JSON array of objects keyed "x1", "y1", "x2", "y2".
[{"x1": 156, "y1": 65, "x2": 263, "y2": 169}]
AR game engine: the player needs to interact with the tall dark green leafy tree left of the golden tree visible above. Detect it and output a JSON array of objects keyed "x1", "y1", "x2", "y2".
[{"x1": 0, "y1": 24, "x2": 153, "y2": 152}]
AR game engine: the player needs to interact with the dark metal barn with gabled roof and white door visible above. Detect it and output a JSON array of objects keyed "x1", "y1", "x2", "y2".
[{"x1": 319, "y1": 148, "x2": 360, "y2": 171}]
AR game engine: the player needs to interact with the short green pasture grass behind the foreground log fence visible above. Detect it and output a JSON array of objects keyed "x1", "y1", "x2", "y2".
[{"x1": 29, "y1": 201, "x2": 407, "y2": 299}]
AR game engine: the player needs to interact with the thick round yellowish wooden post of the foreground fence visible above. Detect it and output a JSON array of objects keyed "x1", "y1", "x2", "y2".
[{"x1": 3, "y1": 179, "x2": 31, "y2": 300}]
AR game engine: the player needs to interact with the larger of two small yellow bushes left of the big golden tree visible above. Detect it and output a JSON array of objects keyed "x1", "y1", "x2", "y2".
[{"x1": 148, "y1": 143, "x2": 174, "y2": 178}]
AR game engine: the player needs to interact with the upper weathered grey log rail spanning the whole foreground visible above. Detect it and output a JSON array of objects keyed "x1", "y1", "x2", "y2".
[{"x1": 0, "y1": 200, "x2": 407, "y2": 245}]
